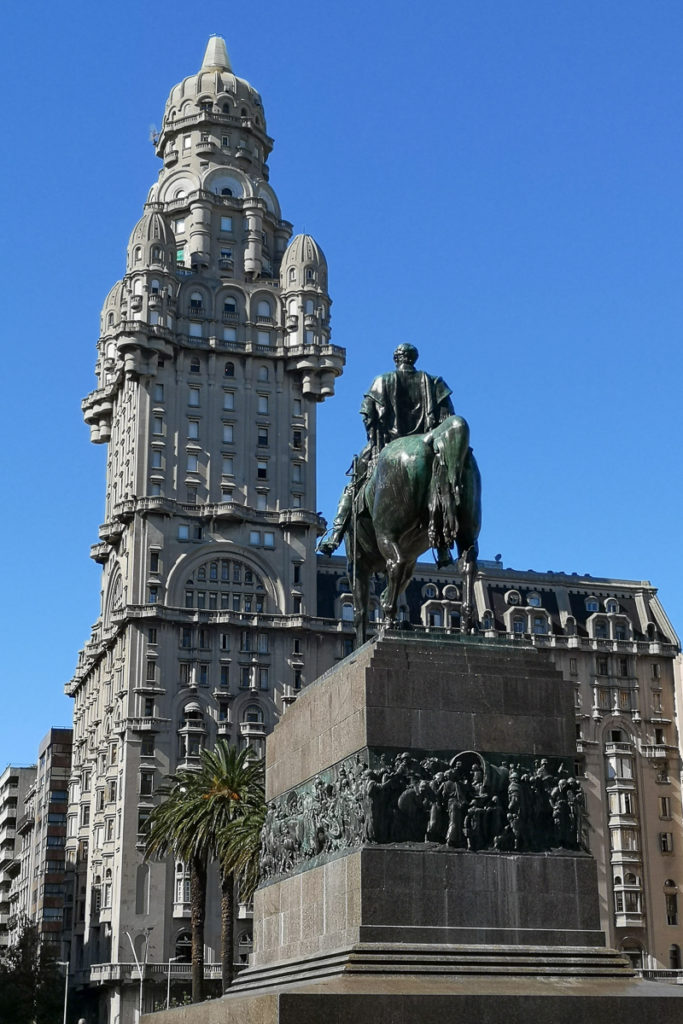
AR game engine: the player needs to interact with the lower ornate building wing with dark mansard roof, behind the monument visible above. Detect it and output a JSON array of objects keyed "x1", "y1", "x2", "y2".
[{"x1": 318, "y1": 558, "x2": 683, "y2": 972}]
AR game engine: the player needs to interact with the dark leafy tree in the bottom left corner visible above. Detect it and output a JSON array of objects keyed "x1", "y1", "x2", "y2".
[{"x1": 0, "y1": 921, "x2": 63, "y2": 1024}]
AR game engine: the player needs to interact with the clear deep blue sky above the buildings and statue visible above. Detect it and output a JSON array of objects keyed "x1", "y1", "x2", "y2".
[{"x1": 0, "y1": 0, "x2": 683, "y2": 766}]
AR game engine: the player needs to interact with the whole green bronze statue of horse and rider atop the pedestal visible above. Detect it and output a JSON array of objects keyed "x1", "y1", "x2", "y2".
[{"x1": 317, "y1": 344, "x2": 481, "y2": 644}]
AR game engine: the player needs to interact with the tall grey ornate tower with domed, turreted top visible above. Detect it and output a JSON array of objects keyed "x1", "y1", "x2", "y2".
[{"x1": 67, "y1": 37, "x2": 344, "y2": 1024}]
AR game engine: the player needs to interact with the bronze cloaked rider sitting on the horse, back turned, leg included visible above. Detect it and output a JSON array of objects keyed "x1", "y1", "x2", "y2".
[{"x1": 317, "y1": 343, "x2": 453, "y2": 565}]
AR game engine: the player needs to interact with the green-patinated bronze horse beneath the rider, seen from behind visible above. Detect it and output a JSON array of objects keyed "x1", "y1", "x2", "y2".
[{"x1": 346, "y1": 416, "x2": 481, "y2": 645}]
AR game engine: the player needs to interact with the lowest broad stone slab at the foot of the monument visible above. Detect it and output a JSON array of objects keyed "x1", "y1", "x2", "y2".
[{"x1": 142, "y1": 970, "x2": 683, "y2": 1024}]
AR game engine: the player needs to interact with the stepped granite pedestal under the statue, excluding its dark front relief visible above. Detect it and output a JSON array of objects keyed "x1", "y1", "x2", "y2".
[{"x1": 145, "y1": 633, "x2": 683, "y2": 1024}]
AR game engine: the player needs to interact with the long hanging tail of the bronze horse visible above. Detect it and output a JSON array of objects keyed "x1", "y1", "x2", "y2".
[{"x1": 428, "y1": 416, "x2": 470, "y2": 548}]
